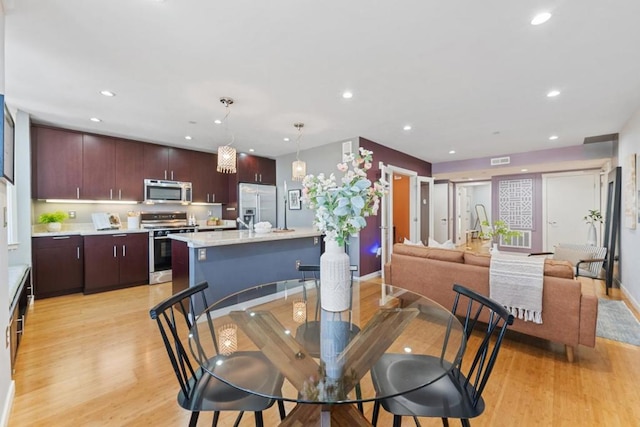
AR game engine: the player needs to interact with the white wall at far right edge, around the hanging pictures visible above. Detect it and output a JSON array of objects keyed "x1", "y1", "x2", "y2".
[{"x1": 618, "y1": 110, "x2": 640, "y2": 310}]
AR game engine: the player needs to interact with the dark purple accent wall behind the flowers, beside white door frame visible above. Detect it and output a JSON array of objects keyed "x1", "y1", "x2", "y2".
[{"x1": 359, "y1": 138, "x2": 431, "y2": 276}]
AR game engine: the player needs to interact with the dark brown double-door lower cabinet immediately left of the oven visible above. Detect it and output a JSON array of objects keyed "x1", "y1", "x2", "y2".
[{"x1": 84, "y1": 233, "x2": 149, "y2": 294}]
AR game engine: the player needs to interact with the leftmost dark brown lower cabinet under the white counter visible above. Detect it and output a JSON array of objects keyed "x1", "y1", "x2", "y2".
[{"x1": 32, "y1": 236, "x2": 84, "y2": 299}]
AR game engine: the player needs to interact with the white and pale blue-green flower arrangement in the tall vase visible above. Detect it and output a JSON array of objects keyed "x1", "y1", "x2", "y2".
[{"x1": 302, "y1": 147, "x2": 386, "y2": 245}]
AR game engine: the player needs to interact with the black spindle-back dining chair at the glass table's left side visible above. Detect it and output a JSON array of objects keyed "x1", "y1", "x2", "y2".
[{"x1": 149, "y1": 282, "x2": 285, "y2": 427}]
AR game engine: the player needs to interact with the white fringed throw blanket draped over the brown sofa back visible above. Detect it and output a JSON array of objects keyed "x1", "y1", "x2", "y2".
[{"x1": 489, "y1": 253, "x2": 544, "y2": 323}]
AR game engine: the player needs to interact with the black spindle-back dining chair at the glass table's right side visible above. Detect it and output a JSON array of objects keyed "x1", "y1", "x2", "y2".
[{"x1": 371, "y1": 284, "x2": 513, "y2": 427}]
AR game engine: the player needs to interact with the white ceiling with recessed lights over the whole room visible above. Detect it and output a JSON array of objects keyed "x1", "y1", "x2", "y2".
[{"x1": 4, "y1": 0, "x2": 640, "y2": 176}]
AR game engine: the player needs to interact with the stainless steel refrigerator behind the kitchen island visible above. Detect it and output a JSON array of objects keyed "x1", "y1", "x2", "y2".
[{"x1": 238, "y1": 184, "x2": 277, "y2": 228}]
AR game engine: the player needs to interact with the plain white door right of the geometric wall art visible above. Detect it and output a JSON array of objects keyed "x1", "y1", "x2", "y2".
[{"x1": 542, "y1": 171, "x2": 602, "y2": 252}]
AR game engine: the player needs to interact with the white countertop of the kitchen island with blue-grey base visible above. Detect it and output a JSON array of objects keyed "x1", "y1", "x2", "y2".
[{"x1": 168, "y1": 227, "x2": 321, "y2": 248}]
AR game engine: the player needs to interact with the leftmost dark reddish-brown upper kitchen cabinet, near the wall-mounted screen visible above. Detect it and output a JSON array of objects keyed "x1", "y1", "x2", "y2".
[{"x1": 32, "y1": 127, "x2": 83, "y2": 199}]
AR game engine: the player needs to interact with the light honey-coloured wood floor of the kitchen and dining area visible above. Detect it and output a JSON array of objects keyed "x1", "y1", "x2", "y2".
[{"x1": 9, "y1": 274, "x2": 640, "y2": 427}]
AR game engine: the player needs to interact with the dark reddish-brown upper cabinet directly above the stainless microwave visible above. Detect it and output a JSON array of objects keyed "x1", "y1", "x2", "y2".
[{"x1": 144, "y1": 144, "x2": 196, "y2": 181}]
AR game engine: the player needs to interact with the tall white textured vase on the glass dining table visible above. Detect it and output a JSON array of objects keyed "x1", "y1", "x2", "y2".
[{"x1": 320, "y1": 240, "x2": 351, "y2": 311}]
